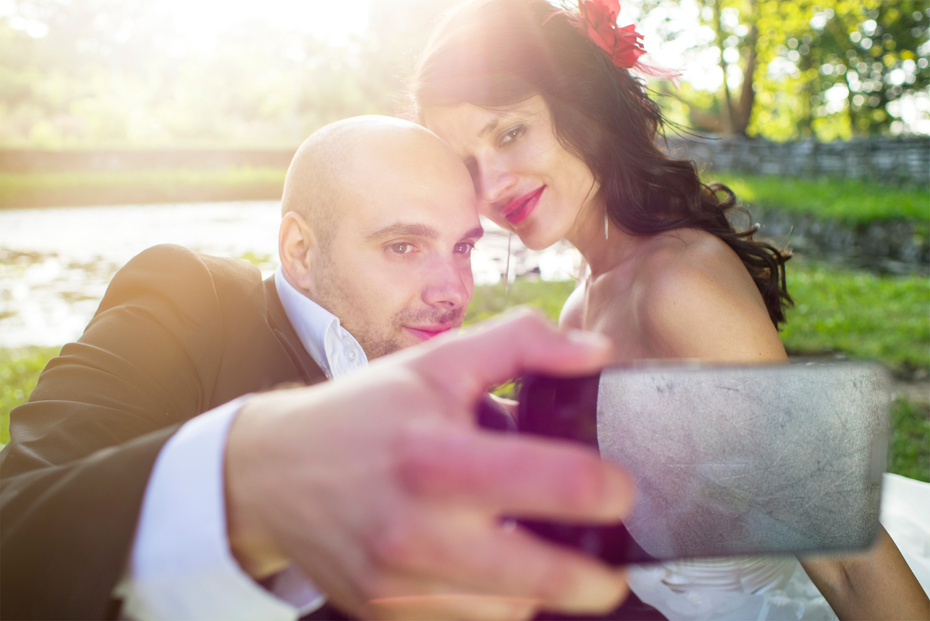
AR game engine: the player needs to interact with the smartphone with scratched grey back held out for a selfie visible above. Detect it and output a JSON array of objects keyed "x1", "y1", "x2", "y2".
[{"x1": 517, "y1": 362, "x2": 891, "y2": 565}]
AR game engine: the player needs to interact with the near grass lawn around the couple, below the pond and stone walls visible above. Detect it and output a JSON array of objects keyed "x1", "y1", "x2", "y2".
[{"x1": 0, "y1": 260, "x2": 930, "y2": 481}]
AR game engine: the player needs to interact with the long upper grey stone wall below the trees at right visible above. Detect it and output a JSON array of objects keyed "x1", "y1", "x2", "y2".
[{"x1": 668, "y1": 136, "x2": 930, "y2": 186}]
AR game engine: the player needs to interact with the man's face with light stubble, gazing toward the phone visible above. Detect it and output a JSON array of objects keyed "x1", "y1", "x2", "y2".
[{"x1": 309, "y1": 150, "x2": 482, "y2": 359}]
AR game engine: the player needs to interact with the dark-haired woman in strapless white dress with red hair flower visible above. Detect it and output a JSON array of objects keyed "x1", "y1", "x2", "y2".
[{"x1": 414, "y1": 0, "x2": 930, "y2": 618}]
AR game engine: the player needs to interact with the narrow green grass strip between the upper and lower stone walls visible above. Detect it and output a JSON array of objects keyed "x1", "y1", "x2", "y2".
[{"x1": 713, "y1": 173, "x2": 930, "y2": 225}]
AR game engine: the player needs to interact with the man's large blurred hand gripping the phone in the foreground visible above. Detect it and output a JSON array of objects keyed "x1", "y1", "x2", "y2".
[{"x1": 226, "y1": 312, "x2": 633, "y2": 619}]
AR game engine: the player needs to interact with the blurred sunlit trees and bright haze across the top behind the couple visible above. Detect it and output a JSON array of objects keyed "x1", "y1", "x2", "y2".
[{"x1": 0, "y1": 0, "x2": 930, "y2": 149}]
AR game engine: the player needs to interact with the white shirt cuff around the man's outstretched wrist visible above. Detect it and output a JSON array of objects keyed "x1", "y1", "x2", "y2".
[{"x1": 117, "y1": 399, "x2": 298, "y2": 621}]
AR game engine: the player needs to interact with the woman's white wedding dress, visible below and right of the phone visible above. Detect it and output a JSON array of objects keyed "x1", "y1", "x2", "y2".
[{"x1": 629, "y1": 473, "x2": 930, "y2": 621}]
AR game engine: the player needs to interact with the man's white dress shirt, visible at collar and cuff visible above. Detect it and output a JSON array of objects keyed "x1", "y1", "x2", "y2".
[{"x1": 115, "y1": 267, "x2": 368, "y2": 621}]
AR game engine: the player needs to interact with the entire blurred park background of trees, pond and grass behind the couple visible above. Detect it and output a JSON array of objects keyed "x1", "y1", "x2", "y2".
[{"x1": 0, "y1": 0, "x2": 930, "y2": 480}]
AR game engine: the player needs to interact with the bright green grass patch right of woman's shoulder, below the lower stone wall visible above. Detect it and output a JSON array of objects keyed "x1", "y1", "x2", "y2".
[{"x1": 782, "y1": 259, "x2": 930, "y2": 376}]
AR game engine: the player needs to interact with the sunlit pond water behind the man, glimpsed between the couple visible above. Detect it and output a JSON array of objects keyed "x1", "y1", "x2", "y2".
[{"x1": 0, "y1": 201, "x2": 578, "y2": 347}]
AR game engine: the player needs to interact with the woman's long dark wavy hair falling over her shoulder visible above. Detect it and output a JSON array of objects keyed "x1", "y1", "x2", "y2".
[{"x1": 413, "y1": 0, "x2": 791, "y2": 327}]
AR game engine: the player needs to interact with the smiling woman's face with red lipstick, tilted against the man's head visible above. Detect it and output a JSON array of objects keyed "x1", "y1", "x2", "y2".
[{"x1": 423, "y1": 95, "x2": 603, "y2": 250}]
